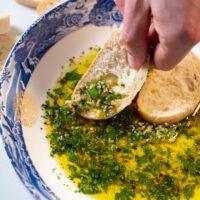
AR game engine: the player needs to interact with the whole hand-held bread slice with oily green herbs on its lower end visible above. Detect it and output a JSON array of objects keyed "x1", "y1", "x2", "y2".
[{"x1": 72, "y1": 31, "x2": 147, "y2": 120}]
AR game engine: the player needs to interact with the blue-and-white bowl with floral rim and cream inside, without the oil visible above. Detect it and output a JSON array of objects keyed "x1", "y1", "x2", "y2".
[{"x1": 0, "y1": 0, "x2": 122, "y2": 200}]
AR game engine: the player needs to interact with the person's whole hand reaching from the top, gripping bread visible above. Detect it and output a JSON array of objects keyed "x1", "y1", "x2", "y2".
[{"x1": 115, "y1": 0, "x2": 200, "y2": 70}]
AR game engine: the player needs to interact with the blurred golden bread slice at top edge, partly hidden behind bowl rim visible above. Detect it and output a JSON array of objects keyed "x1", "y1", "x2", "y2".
[{"x1": 37, "y1": 0, "x2": 64, "y2": 15}]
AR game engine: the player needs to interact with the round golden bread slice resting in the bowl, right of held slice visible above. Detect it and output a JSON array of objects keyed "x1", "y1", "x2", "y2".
[{"x1": 137, "y1": 52, "x2": 200, "y2": 124}]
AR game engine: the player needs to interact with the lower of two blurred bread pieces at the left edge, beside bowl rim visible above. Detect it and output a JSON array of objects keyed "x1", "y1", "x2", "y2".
[{"x1": 0, "y1": 34, "x2": 18, "y2": 70}]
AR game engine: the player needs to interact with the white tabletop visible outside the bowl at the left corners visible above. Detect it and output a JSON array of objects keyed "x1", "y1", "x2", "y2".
[{"x1": 0, "y1": 0, "x2": 39, "y2": 200}]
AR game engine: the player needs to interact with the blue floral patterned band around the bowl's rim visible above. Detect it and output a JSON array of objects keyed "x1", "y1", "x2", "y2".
[{"x1": 0, "y1": 0, "x2": 122, "y2": 199}]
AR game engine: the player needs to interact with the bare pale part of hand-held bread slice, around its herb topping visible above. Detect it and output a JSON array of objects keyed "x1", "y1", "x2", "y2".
[{"x1": 72, "y1": 31, "x2": 147, "y2": 120}]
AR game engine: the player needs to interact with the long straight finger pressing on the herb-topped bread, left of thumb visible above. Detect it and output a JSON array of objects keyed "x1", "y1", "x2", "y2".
[{"x1": 122, "y1": 0, "x2": 151, "y2": 67}]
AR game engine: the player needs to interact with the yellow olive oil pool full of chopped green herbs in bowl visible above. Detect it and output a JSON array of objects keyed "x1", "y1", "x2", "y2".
[{"x1": 43, "y1": 49, "x2": 200, "y2": 200}]
